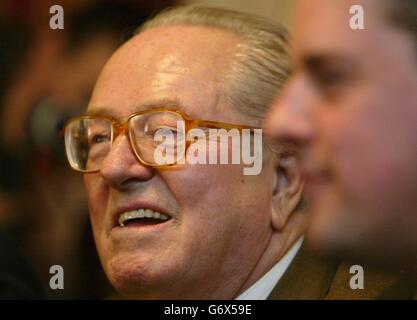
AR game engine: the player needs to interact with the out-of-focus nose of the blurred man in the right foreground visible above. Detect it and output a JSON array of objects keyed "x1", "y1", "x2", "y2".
[{"x1": 265, "y1": 80, "x2": 314, "y2": 145}]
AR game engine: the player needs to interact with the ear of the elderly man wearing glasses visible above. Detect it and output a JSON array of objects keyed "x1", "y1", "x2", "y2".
[{"x1": 271, "y1": 155, "x2": 304, "y2": 231}]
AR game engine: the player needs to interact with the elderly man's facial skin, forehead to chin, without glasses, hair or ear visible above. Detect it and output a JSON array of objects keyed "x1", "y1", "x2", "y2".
[{"x1": 85, "y1": 26, "x2": 273, "y2": 298}]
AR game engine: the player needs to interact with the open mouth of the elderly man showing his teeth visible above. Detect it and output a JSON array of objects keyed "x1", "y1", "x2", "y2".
[{"x1": 118, "y1": 208, "x2": 171, "y2": 227}]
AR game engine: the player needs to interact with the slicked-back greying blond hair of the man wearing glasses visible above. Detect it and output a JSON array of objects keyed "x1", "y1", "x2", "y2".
[{"x1": 136, "y1": 6, "x2": 290, "y2": 124}]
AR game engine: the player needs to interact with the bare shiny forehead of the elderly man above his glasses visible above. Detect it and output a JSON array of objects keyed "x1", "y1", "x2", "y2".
[{"x1": 88, "y1": 26, "x2": 238, "y2": 117}]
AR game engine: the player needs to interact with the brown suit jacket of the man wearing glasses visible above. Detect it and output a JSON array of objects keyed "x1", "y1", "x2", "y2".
[{"x1": 268, "y1": 245, "x2": 416, "y2": 300}]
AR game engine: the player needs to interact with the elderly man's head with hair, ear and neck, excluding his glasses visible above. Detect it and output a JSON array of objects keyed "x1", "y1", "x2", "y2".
[{"x1": 67, "y1": 7, "x2": 304, "y2": 298}]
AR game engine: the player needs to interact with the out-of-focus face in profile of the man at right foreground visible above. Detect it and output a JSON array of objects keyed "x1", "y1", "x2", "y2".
[{"x1": 267, "y1": 0, "x2": 417, "y2": 266}]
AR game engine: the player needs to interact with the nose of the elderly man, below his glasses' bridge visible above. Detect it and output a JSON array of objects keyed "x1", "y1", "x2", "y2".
[{"x1": 100, "y1": 135, "x2": 154, "y2": 190}]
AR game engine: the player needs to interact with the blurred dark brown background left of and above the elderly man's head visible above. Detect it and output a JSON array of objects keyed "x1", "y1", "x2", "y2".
[{"x1": 0, "y1": 0, "x2": 294, "y2": 299}]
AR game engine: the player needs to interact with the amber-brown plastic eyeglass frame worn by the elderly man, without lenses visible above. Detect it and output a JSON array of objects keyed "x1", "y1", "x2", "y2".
[{"x1": 61, "y1": 107, "x2": 260, "y2": 174}]
